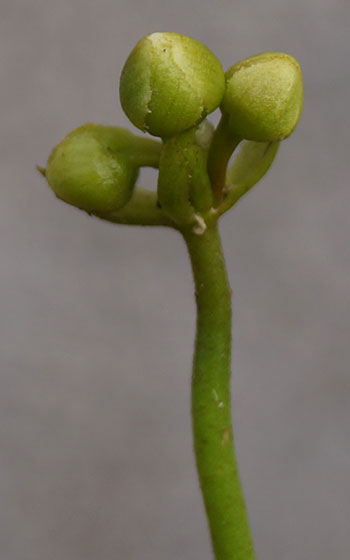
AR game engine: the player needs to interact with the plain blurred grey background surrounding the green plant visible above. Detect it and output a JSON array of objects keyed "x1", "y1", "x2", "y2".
[{"x1": 0, "y1": 0, "x2": 350, "y2": 560}]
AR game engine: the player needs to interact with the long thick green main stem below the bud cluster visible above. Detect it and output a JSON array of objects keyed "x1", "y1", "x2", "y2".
[{"x1": 183, "y1": 225, "x2": 255, "y2": 560}]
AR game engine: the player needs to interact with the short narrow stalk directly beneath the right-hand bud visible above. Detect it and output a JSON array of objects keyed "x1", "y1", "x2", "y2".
[{"x1": 208, "y1": 115, "x2": 241, "y2": 207}]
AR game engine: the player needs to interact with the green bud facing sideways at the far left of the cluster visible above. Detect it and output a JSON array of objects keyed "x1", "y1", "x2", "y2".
[{"x1": 45, "y1": 123, "x2": 138, "y2": 213}]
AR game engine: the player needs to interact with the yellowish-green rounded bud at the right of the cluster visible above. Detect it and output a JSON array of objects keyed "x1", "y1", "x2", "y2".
[{"x1": 221, "y1": 52, "x2": 303, "y2": 142}]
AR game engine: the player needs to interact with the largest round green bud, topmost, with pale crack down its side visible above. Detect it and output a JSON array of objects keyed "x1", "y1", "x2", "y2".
[{"x1": 120, "y1": 33, "x2": 225, "y2": 138}]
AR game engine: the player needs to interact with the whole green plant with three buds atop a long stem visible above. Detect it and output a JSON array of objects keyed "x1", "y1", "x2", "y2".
[{"x1": 40, "y1": 33, "x2": 302, "y2": 560}]
